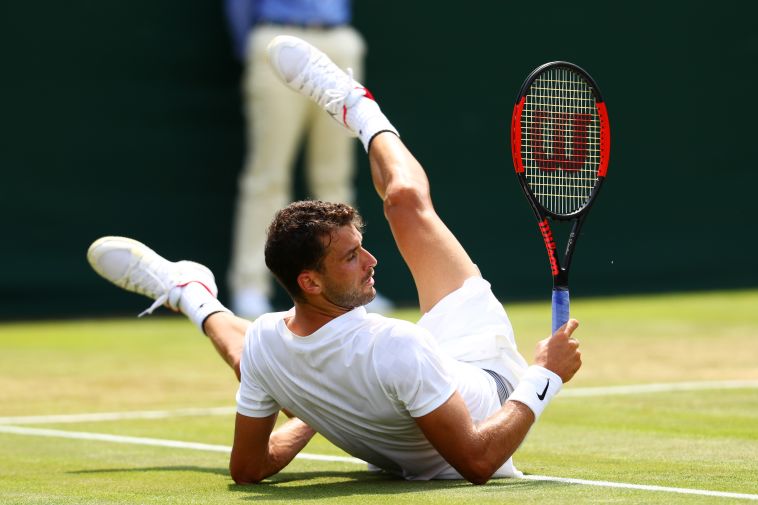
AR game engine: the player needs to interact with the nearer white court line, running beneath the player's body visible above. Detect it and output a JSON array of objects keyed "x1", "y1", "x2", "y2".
[{"x1": 0, "y1": 426, "x2": 758, "y2": 501}]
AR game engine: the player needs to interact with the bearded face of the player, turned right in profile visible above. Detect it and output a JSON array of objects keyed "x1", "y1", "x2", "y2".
[{"x1": 322, "y1": 225, "x2": 377, "y2": 308}]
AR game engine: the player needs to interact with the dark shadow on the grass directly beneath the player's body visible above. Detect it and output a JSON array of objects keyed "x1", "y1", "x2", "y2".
[{"x1": 229, "y1": 471, "x2": 542, "y2": 503}]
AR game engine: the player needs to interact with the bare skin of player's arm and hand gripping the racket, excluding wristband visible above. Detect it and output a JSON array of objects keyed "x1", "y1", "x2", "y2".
[{"x1": 416, "y1": 319, "x2": 581, "y2": 484}]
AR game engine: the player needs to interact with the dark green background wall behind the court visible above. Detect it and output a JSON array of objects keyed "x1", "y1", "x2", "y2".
[{"x1": 0, "y1": 0, "x2": 758, "y2": 319}]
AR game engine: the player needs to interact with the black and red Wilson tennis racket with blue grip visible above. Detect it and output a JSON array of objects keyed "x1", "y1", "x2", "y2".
[{"x1": 511, "y1": 61, "x2": 611, "y2": 333}]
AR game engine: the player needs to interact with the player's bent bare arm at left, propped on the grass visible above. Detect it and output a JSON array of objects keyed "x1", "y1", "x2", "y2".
[{"x1": 229, "y1": 413, "x2": 316, "y2": 484}]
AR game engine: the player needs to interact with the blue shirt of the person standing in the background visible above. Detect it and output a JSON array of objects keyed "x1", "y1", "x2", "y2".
[{"x1": 224, "y1": 0, "x2": 352, "y2": 59}]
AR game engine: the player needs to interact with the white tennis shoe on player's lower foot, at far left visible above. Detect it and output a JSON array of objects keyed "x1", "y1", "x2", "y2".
[{"x1": 87, "y1": 237, "x2": 218, "y2": 317}]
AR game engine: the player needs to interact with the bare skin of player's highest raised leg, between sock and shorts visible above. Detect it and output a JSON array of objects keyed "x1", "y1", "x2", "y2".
[{"x1": 369, "y1": 132, "x2": 480, "y2": 312}]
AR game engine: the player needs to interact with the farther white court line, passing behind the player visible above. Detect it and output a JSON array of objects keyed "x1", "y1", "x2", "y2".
[{"x1": 0, "y1": 380, "x2": 758, "y2": 425}]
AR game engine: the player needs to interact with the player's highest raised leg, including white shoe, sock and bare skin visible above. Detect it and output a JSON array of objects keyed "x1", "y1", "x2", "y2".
[{"x1": 269, "y1": 36, "x2": 479, "y2": 311}]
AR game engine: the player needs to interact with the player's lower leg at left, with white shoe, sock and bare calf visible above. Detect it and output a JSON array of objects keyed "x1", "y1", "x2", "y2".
[{"x1": 87, "y1": 237, "x2": 250, "y2": 378}]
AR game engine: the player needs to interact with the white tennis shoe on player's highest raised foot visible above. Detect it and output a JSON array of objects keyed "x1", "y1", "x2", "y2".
[{"x1": 268, "y1": 35, "x2": 373, "y2": 136}]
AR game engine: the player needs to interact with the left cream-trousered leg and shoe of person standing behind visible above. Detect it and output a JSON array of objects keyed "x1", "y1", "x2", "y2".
[{"x1": 229, "y1": 27, "x2": 310, "y2": 317}]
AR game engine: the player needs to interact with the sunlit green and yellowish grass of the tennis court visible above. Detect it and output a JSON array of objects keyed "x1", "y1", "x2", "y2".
[{"x1": 0, "y1": 291, "x2": 758, "y2": 505}]
